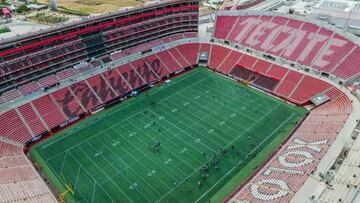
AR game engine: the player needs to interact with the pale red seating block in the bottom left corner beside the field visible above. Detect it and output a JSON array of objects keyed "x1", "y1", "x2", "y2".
[{"x1": 0, "y1": 141, "x2": 57, "y2": 203}]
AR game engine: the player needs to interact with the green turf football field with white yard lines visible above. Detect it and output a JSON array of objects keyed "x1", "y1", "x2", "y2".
[{"x1": 30, "y1": 68, "x2": 306, "y2": 203}]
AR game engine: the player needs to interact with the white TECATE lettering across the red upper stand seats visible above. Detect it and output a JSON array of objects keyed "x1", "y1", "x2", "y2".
[{"x1": 231, "y1": 16, "x2": 349, "y2": 67}]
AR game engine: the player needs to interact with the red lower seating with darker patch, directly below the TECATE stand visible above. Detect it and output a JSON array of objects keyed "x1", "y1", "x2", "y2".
[{"x1": 224, "y1": 51, "x2": 330, "y2": 105}]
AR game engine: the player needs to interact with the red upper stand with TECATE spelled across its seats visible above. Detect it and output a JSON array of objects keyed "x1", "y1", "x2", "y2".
[{"x1": 214, "y1": 14, "x2": 360, "y2": 80}]
